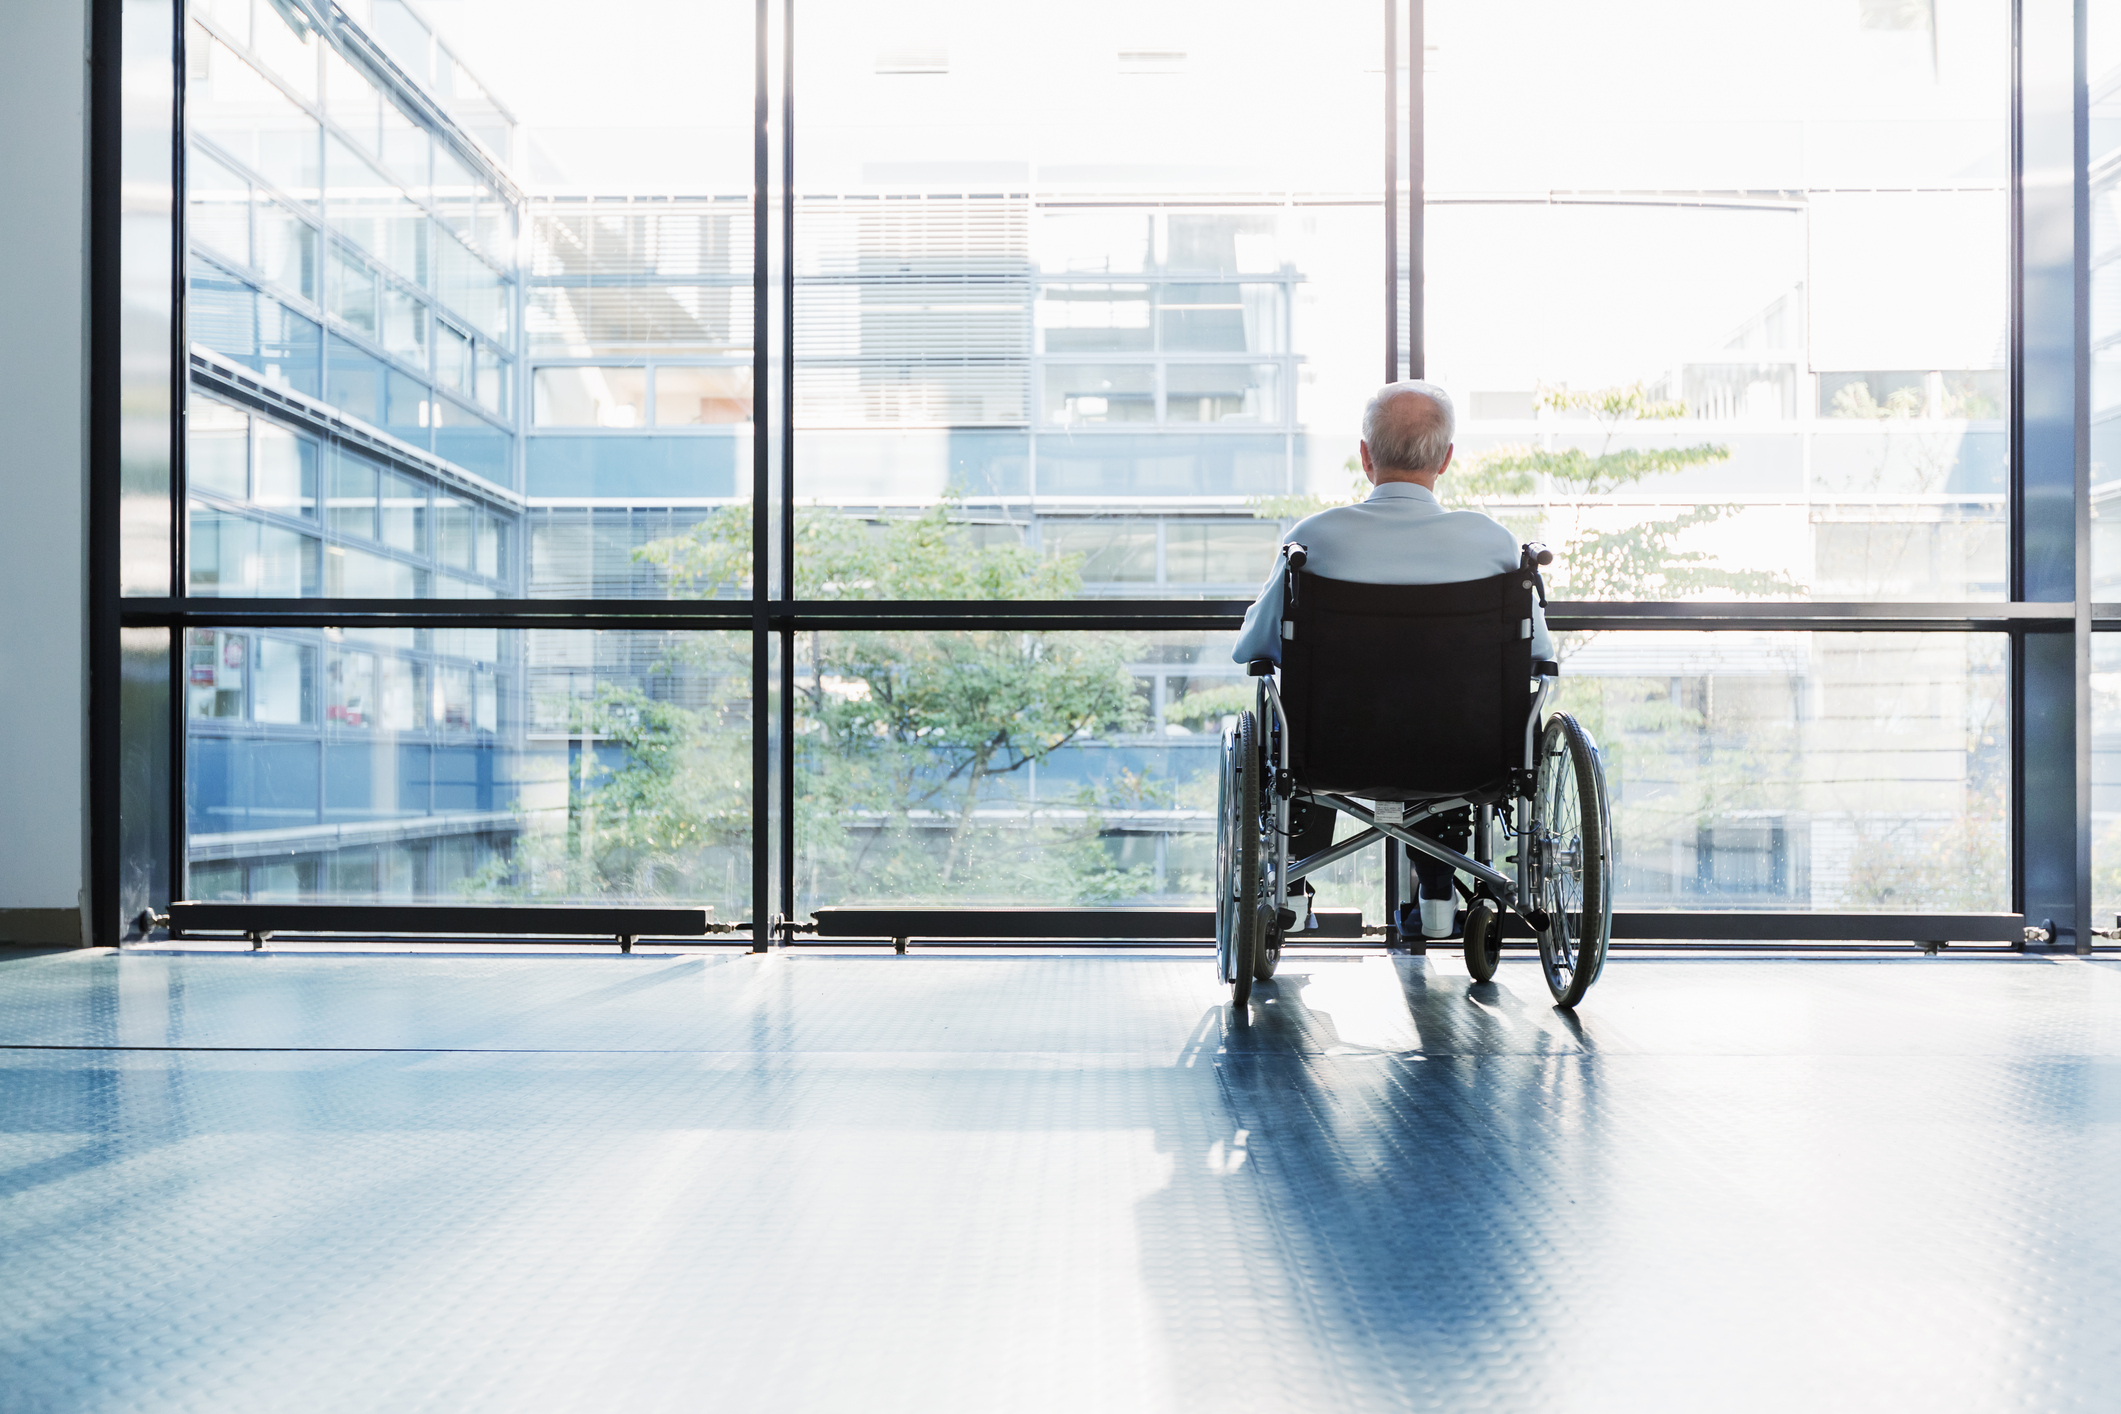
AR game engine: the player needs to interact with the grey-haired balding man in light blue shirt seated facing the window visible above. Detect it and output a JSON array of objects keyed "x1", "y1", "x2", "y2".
[{"x1": 1230, "y1": 379, "x2": 1555, "y2": 937}]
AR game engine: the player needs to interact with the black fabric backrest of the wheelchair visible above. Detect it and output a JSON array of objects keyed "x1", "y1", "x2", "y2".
[{"x1": 1281, "y1": 570, "x2": 1536, "y2": 799}]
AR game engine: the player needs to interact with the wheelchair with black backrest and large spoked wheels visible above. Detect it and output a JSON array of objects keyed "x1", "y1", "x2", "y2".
[{"x1": 1215, "y1": 545, "x2": 1612, "y2": 1007}]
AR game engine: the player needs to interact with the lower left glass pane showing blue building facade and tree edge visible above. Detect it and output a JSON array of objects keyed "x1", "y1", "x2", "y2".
[{"x1": 185, "y1": 630, "x2": 751, "y2": 920}]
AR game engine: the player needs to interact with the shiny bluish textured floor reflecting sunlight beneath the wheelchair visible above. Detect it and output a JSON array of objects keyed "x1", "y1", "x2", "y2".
[{"x1": 0, "y1": 954, "x2": 2121, "y2": 1414}]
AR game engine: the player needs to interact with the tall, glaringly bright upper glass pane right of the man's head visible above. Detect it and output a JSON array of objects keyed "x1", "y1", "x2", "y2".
[{"x1": 1425, "y1": 0, "x2": 2011, "y2": 600}]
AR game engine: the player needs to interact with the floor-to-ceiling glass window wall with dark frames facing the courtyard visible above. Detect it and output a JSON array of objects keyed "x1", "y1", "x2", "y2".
[{"x1": 125, "y1": 0, "x2": 2070, "y2": 941}]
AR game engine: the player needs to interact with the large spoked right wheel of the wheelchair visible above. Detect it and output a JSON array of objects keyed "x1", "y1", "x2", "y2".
[{"x1": 1531, "y1": 712, "x2": 1612, "y2": 1007}]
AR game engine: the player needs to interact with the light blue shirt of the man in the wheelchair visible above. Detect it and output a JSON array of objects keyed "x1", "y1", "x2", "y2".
[{"x1": 1230, "y1": 481, "x2": 1555, "y2": 664}]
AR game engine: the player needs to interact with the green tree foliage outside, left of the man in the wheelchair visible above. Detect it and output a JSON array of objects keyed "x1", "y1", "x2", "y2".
[{"x1": 488, "y1": 505, "x2": 1160, "y2": 901}]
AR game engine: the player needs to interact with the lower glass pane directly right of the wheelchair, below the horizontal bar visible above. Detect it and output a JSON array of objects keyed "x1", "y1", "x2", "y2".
[{"x1": 1555, "y1": 632, "x2": 2011, "y2": 912}]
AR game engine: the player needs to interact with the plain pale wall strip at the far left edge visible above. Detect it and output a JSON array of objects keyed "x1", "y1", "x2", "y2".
[{"x1": 0, "y1": 0, "x2": 89, "y2": 943}]
